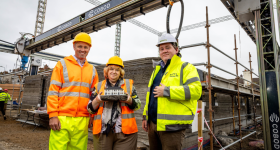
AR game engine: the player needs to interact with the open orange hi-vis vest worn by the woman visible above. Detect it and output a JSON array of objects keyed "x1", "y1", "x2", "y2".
[{"x1": 92, "y1": 79, "x2": 138, "y2": 134}]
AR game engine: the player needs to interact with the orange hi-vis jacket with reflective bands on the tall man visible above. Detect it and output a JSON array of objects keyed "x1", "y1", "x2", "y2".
[{"x1": 47, "y1": 56, "x2": 98, "y2": 118}]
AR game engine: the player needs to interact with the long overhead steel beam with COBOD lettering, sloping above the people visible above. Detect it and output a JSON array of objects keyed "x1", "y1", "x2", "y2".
[{"x1": 25, "y1": 0, "x2": 177, "y2": 53}]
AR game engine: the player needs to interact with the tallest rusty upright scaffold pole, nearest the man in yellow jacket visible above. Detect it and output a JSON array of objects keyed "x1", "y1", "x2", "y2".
[{"x1": 205, "y1": 7, "x2": 214, "y2": 150}]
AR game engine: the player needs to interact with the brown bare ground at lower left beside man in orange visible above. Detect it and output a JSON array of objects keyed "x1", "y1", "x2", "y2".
[{"x1": 0, "y1": 116, "x2": 93, "y2": 150}]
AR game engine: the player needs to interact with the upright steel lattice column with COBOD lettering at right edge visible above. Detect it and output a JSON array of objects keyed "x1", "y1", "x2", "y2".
[{"x1": 255, "y1": 0, "x2": 280, "y2": 150}]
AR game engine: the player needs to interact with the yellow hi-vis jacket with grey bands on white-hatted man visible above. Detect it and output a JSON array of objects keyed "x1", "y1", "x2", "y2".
[{"x1": 143, "y1": 55, "x2": 202, "y2": 131}]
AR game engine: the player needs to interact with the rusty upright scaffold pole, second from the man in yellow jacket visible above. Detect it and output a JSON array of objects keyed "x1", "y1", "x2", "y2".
[{"x1": 234, "y1": 35, "x2": 242, "y2": 149}]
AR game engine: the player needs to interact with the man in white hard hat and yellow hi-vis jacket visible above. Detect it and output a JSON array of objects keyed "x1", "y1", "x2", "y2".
[{"x1": 142, "y1": 34, "x2": 202, "y2": 150}]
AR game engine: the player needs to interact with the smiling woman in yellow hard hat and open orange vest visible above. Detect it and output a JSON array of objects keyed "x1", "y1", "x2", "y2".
[{"x1": 87, "y1": 56, "x2": 141, "y2": 150}]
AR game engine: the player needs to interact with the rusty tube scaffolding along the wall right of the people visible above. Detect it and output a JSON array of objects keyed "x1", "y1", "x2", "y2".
[{"x1": 180, "y1": 7, "x2": 260, "y2": 150}]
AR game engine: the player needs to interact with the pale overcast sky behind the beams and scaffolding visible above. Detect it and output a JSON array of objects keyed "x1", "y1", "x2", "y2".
[{"x1": 0, "y1": 0, "x2": 276, "y2": 78}]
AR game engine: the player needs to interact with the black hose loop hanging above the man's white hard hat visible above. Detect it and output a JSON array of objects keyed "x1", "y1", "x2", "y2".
[{"x1": 166, "y1": 0, "x2": 184, "y2": 40}]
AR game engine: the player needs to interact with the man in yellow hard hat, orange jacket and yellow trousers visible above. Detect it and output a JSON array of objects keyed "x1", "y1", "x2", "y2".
[{"x1": 47, "y1": 32, "x2": 98, "y2": 150}]
